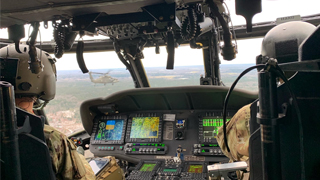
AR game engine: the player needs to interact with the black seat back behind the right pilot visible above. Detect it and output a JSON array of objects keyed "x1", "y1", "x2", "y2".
[{"x1": 249, "y1": 72, "x2": 320, "y2": 180}]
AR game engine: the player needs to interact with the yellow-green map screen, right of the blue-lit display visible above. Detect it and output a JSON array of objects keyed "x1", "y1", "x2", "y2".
[{"x1": 130, "y1": 117, "x2": 160, "y2": 138}]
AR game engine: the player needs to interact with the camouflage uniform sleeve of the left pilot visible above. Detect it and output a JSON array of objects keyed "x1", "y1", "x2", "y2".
[{"x1": 44, "y1": 125, "x2": 96, "y2": 180}]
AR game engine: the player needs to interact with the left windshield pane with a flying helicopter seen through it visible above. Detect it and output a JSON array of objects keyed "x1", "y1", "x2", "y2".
[{"x1": 45, "y1": 53, "x2": 134, "y2": 135}]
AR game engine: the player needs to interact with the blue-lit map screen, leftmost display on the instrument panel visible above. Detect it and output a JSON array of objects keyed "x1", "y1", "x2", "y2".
[{"x1": 94, "y1": 119, "x2": 124, "y2": 141}]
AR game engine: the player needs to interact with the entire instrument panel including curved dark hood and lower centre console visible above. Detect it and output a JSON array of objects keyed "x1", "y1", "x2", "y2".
[{"x1": 80, "y1": 86, "x2": 257, "y2": 180}]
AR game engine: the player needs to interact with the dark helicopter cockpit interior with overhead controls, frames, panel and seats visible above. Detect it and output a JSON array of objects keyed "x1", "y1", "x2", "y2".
[{"x1": 0, "y1": 0, "x2": 320, "y2": 180}]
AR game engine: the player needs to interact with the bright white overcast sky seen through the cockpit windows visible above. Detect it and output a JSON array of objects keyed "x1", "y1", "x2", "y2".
[{"x1": 0, "y1": 0, "x2": 320, "y2": 70}]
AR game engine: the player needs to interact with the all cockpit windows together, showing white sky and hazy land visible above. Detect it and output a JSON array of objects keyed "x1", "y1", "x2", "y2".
[{"x1": 0, "y1": 0, "x2": 320, "y2": 134}]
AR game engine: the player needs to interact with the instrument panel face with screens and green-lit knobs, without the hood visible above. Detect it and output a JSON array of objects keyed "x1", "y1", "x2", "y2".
[{"x1": 90, "y1": 110, "x2": 235, "y2": 162}]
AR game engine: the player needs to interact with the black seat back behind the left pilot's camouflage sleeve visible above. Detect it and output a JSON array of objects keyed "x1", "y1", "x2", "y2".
[{"x1": 17, "y1": 108, "x2": 56, "y2": 180}]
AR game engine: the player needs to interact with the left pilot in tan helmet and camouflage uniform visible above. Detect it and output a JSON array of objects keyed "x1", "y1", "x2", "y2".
[{"x1": 0, "y1": 44, "x2": 96, "y2": 179}]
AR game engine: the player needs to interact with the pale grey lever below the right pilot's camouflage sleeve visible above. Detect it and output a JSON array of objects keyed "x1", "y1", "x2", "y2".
[{"x1": 207, "y1": 161, "x2": 248, "y2": 179}]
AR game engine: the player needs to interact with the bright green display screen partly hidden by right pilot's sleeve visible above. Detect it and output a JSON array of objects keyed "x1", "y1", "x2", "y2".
[{"x1": 202, "y1": 119, "x2": 230, "y2": 138}]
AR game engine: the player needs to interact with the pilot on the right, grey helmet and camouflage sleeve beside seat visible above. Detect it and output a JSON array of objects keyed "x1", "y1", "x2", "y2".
[{"x1": 217, "y1": 21, "x2": 316, "y2": 179}]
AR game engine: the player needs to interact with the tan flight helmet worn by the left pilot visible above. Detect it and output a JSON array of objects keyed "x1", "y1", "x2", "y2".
[{"x1": 0, "y1": 44, "x2": 57, "y2": 102}]
